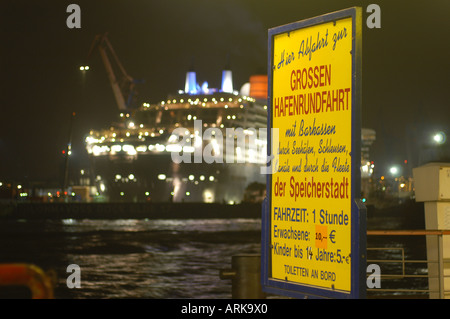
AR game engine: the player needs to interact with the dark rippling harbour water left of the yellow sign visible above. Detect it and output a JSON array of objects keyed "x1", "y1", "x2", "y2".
[{"x1": 0, "y1": 219, "x2": 261, "y2": 298}]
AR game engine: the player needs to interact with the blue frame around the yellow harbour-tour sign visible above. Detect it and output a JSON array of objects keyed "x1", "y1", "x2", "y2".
[{"x1": 261, "y1": 7, "x2": 367, "y2": 299}]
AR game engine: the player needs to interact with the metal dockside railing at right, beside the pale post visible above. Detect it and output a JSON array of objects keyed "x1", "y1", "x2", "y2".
[{"x1": 367, "y1": 230, "x2": 450, "y2": 299}]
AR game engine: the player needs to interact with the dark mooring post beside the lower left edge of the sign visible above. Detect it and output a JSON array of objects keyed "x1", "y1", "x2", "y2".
[{"x1": 220, "y1": 254, "x2": 266, "y2": 299}]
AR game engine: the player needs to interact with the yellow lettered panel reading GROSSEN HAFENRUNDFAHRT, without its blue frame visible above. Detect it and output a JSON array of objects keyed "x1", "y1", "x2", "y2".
[{"x1": 270, "y1": 17, "x2": 352, "y2": 293}]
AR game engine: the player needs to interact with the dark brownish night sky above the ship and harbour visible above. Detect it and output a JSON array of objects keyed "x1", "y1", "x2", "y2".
[{"x1": 0, "y1": 0, "x2": 450, "y2": 183}]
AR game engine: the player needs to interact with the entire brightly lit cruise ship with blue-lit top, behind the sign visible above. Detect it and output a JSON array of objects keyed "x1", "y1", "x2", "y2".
[{"x1": 86, "y1": 65, "x2": 267, "y2": 203}]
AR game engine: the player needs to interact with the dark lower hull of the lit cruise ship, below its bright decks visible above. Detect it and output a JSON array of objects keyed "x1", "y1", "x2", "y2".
[{"x1": 91, "y1": 153, "x2": 266, "y2": 204}]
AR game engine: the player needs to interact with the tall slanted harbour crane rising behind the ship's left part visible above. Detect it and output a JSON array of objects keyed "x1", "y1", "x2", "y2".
[{"x1": 88, "y1": 33, "x2": 142, "y2": 112}]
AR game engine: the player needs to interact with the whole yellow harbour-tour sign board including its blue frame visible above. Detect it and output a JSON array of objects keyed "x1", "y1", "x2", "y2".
[{"x1": 261, "y1": 8, "x2": 366, "y2": 298}]
